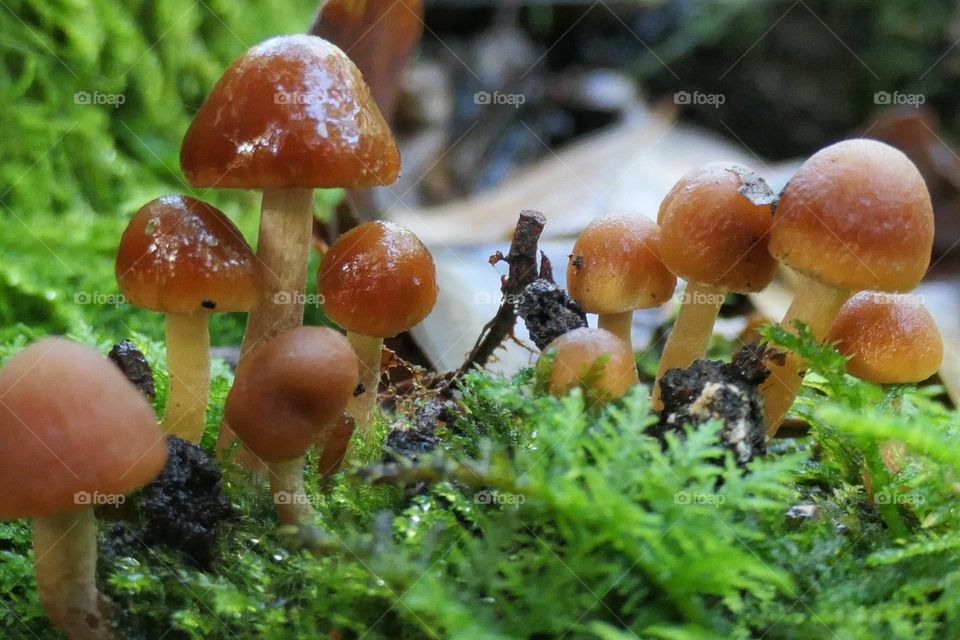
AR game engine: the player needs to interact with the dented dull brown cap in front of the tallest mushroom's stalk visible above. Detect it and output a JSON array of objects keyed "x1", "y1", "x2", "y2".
[{"x1": 225, "y1": 327, "x2": 360, "y2": 462}]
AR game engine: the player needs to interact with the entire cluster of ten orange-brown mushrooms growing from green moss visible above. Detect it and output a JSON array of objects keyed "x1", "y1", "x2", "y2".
[{"x1": 0, "y1": 30, "x2": 942, "y2": 640}]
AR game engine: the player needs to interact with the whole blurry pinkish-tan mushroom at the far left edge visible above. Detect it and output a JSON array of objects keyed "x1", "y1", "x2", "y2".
[{"x1": 0, "y1": 338, "x2": 167, "y2": 640}]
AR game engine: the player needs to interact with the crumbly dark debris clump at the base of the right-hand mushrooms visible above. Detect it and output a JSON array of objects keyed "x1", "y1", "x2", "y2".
[{"x1": 655, "y1": 345, "x2": 770, "y2": 466}]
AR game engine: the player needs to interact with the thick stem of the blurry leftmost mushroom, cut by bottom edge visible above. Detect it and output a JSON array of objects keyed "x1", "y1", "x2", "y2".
[{"x1": 33, "y1": 507, "x2": 116, "y2": 640}]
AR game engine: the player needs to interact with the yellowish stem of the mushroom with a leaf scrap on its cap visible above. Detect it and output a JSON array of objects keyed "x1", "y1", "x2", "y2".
[{"x1": 653, "y1": 282, "x2": 724, "y2": 411}]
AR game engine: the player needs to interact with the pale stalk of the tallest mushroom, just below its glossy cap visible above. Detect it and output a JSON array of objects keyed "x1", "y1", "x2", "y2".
[{"x1": 240, "y1": 189, "x2": 313, "y2": 360}]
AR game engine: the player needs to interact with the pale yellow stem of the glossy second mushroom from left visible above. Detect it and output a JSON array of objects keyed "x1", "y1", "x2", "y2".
[{"x1": 163, "y1": 313, "x2": 210, "y2": 442}]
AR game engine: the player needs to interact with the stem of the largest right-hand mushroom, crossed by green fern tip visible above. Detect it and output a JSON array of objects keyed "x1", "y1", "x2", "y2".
[{"x1": 760, "y1": 276, "x2": 850, "y2": 438}]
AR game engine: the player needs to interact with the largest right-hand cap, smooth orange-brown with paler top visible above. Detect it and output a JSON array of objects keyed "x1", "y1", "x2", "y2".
[{"x1": 770, "y1": 139, "x2": 933, "y2": 291}]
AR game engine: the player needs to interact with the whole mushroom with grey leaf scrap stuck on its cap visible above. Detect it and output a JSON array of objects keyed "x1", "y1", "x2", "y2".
[{"x1": 653, "y1": 163, "x2": 777, "y2": 409}]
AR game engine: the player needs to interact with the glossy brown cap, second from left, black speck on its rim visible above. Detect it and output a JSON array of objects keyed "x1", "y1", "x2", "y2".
[{"x1": 116, "y1": 195, "x2": 261, "y2": 314}]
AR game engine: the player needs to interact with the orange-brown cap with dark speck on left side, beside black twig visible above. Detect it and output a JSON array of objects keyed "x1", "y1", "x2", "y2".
[{"x1": 567, "y1": 213, "x2": 677, "y2": 313}]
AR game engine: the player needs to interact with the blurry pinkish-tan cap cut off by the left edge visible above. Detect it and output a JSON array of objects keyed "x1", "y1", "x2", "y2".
[{"x1": 0, "y1": 338, "x2": 167, "y2": 518}]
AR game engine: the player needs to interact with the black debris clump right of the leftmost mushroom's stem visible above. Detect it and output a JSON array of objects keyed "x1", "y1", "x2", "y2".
[{"x1": 139, "y1": 436, "x2": 236, "y2": 567}]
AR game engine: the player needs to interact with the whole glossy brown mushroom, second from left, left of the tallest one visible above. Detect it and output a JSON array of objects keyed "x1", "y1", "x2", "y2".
[{"x1": 116, "y1": 195, "x2": 261, "y2": 442}]
